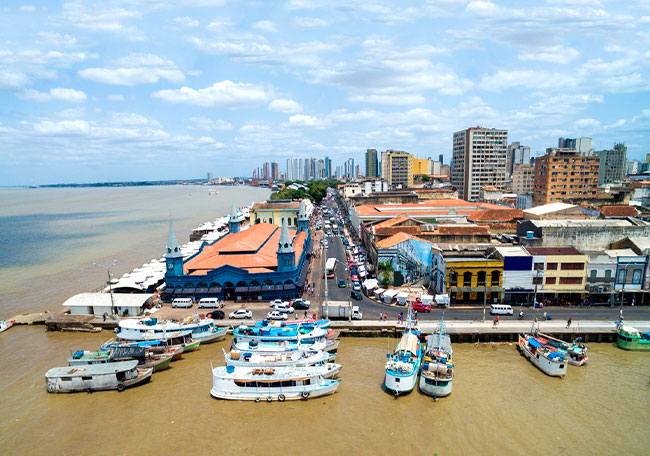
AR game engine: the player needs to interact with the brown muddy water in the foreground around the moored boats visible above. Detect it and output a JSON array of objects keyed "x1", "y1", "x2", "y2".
[{"x1": 0, "y1": 327, "x2": 650, "y2": 455}]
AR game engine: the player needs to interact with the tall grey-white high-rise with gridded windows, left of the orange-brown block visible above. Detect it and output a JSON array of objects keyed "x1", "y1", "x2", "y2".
[{"x1": 451, "y1": 127, "x2": 508, "y2": 201}]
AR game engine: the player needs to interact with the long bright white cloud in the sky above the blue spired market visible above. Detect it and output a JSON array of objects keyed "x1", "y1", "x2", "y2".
[{"x1": 152, "y1": 81, "x2": 271, "y2": 109}]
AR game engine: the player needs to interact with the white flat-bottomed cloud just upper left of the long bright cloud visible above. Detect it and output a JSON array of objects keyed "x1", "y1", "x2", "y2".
[{"x1": 79, "y1": 54, "x2": 185, "y2": 86}]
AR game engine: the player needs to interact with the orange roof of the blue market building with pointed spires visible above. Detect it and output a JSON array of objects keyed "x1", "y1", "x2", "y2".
[{"x1": 183, "y1": 223, "x2": 307, "y2": 275}]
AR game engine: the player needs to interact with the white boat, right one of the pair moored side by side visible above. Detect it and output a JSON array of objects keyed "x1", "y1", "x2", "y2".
[{"x1": 419, "y1": 320, "x2": 454, "y2": 397}]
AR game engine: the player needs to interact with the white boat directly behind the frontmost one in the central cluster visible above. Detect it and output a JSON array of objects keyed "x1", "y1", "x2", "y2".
[{"x1": 222, "y1": 349, "x2": 342, "y2": 375}]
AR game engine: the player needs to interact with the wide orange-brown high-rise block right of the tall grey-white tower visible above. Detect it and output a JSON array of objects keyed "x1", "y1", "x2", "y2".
[{"x1": 533, "y1": 148, "x2": 600, "y2": 206}]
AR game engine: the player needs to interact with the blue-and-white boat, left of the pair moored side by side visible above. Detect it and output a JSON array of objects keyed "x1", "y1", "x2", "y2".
[{"x1": 384, "y1": 309, "x2": 422, "y2": 397}]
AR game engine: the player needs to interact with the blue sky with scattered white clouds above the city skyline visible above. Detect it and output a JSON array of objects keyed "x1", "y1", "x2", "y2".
[{"x1": 0, "y1": 0, "x2": 650, "y2": 186}]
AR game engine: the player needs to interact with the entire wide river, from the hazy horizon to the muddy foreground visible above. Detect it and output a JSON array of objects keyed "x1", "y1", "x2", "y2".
[{"x1": 0, "y1": 187, "x2": 650, "y2": 456}]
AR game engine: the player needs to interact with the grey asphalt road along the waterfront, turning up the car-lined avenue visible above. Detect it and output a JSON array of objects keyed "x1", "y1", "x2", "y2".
[{"x1": 318, "y1": 198, "x2": 650, "y2": 322}]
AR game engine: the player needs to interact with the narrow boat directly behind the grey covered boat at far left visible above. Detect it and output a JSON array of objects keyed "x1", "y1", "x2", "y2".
[{"x1": 68, "y1": 347, "x2": 173, "y2": 372}]
